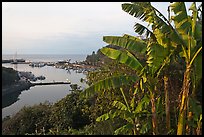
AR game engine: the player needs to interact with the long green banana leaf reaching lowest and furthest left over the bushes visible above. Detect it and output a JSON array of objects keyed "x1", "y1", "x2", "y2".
[{"x1": 81, "y1": 75, "x2": 138, "y2": 97}]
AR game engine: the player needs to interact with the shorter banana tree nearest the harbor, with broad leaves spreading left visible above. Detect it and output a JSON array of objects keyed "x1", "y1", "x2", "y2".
[{"x1": 81, "y1": 34, "x2": 171, "y2": 134}]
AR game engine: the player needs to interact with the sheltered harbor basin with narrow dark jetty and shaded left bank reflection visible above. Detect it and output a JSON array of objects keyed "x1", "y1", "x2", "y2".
[{"x1": 2, "y1": 59, "x2": 87, "y2": 118}]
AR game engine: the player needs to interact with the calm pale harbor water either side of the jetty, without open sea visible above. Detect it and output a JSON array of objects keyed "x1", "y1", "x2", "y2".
[{"x1": 2, "y1": 56, "x2": 87, "y2": 118}]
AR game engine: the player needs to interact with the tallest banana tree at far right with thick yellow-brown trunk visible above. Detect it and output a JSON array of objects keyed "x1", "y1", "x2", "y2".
[{"x1": 123, "y1": 2, "x2": 202, "y2": 134}]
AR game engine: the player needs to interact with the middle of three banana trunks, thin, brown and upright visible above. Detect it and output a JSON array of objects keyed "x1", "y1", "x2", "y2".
[{"x1": 164, "y1": 75, "x2": 170, "y2": 133}]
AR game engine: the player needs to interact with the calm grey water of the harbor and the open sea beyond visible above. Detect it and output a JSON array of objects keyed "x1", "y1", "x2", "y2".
[{"x1": 2, "y1": 54, "x2": 88, "y2": 119}]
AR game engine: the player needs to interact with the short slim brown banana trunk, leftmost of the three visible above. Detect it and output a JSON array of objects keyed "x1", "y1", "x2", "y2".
[{"x1": 150, "y1": 92, "x2": 158, "y2": 135}]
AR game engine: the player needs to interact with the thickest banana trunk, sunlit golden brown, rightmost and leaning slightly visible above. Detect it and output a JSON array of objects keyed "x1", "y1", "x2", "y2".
[{"x1": 177, "y1": 64, "x2": 191, "y2": 135}]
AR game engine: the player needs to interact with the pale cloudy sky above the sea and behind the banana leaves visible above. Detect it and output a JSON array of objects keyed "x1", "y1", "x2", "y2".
[{"x1": 2, "y1": 2, "x2": 201, "y2": 54}]
